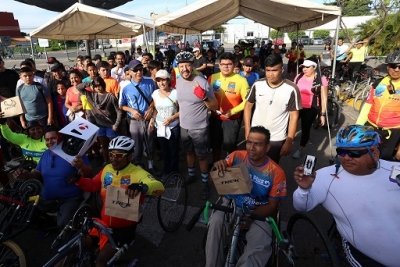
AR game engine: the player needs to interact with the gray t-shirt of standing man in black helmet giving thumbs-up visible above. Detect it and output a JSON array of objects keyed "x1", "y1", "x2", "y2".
[{"x1": 176, "y1": 76, "x2": 215, "y2": 130}]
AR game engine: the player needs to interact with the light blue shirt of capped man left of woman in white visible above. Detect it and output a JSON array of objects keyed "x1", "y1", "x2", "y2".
[{"x1": 119, "y1": 77, "x2": 156, "y2": 118}]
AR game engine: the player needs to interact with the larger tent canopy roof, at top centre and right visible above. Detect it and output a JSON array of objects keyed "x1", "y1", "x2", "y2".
[{"x1": 155, "y1": 0, "x2": 341, "y2": 34}]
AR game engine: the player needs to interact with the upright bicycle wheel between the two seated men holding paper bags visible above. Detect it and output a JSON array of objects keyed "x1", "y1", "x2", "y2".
[{"x1": 157, "y1": 173, "x2": 188, "y2": 232}]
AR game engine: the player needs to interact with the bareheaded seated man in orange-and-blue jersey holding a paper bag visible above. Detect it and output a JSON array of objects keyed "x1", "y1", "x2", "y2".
[{"x1": 206, "y1": 126, "x2": 286, "y2": 267}]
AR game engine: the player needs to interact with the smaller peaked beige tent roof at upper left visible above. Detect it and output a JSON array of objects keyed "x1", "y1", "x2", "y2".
[{"x1": 31, "y1": 3, "x2": 154, "y2": 40}]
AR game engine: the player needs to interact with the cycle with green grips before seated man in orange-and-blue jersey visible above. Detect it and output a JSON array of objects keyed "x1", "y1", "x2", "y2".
[{"x1": 186, "y1": 197, "x2": 296, "y2": 267}]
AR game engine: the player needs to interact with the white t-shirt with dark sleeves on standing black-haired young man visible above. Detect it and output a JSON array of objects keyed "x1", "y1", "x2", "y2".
[{"x1": 246, "y1": 78, "x2": 302, "y2": 141}]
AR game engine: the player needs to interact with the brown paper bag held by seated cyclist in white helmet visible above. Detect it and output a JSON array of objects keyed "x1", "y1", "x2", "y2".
[{"x1": 104, "y1": 185, "x2": 143, "y2": 222}]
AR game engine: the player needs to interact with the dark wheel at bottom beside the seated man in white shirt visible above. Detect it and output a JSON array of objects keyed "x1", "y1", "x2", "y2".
[{"x1": 287, "y1": 213, "x2": 339, "y2": 267}]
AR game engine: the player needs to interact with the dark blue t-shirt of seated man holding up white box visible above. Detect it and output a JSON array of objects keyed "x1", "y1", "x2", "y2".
[{"x1": 36, "y1": 149, "x2": 90, "y2": 200}]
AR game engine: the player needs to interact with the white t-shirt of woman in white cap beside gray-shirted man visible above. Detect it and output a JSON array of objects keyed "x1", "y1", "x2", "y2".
[{"x1": 151, "y1": 89, "x2": 179, "y2": 129}]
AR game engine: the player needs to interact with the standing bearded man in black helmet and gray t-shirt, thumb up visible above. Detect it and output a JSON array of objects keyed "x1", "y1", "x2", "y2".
[{"x1": 176, "y1": 51, "x2": 218, "y2": 199}]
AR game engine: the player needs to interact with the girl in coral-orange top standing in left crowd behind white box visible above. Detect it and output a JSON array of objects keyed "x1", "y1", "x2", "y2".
[{"x1": 65, "y1": 70, "x2": 84, "y2": 121}]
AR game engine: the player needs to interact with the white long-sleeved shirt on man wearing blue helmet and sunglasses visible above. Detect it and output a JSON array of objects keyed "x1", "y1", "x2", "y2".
[{"x1": 293, "y1": 160, "x2": 400, "y2": 267}]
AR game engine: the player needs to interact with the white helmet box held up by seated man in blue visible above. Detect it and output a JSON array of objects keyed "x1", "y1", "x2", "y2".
[{"x1": 52, "y1": 118, "x2": 99, "y2": 163}]
